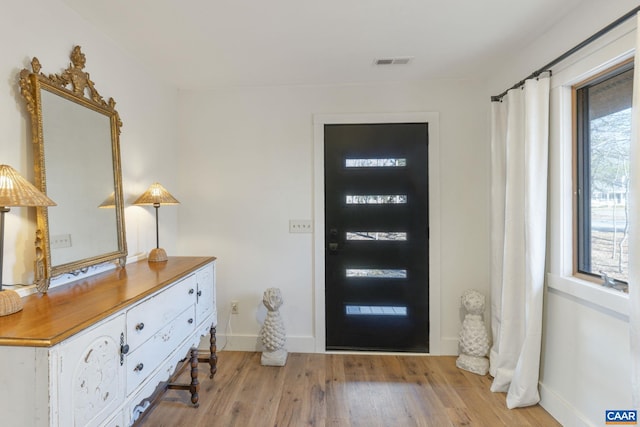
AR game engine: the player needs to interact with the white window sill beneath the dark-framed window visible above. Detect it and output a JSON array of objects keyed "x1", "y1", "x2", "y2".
[{"x1": 547, "y1": 273, "x2": 629, "y2": 318}]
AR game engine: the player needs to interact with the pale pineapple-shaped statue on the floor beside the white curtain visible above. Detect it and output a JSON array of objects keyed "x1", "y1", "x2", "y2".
[{"x1": 456, "y1": 289, "x2": 489, "y2": 375}]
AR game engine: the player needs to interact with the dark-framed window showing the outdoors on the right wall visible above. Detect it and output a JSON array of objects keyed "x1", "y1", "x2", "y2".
[{"x1": 574, "y1": 62, "x2": 633, "y2": 290}]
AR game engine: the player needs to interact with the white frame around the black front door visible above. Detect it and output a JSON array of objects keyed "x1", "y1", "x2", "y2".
[{"x1": 313, "y1": 112, "x2": 441, "y2": 354}]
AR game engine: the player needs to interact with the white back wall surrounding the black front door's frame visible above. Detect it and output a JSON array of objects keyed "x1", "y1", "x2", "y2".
[{"x1": 178, "y1": 80, "x2": 489, "y2": 354}]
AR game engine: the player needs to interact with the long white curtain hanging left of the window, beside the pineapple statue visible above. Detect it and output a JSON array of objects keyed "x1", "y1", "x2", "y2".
[{"x1": 489, "y1": 77, "x2": 549, "y2": 408}]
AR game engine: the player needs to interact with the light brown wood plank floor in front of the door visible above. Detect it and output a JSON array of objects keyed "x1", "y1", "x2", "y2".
[{"x1": 141, "y1": 351, "x2": 560, "y2": 427}]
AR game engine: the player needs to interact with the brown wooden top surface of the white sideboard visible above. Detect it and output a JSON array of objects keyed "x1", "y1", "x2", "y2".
[{"x1": 0, "y1": 257, "x2": 215, "y2": 347}]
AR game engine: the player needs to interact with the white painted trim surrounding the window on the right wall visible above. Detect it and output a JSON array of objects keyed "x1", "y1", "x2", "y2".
[{"x1": 547, "y1": 19, "x2": 640, "y2": 318}]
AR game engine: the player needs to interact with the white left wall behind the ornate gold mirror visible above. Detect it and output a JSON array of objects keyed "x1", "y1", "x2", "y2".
[{"x1": 0, "y1": 0, "x2": 179, "y2": 284}]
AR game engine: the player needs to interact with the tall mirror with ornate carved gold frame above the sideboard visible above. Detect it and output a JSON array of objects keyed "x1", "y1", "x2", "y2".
[{"x1": 20, "y1": 46, "x2": 127, "y2": 292}]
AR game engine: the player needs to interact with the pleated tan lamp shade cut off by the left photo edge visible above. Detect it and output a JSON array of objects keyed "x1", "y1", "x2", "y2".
[{"x1": 0, "y1": 165, "x2": 56, "y2": 207}]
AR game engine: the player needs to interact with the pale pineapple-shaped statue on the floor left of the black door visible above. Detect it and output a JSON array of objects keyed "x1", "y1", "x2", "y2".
[{"x1": 260, "y1": 288, "x2": 287, "y2": 366}]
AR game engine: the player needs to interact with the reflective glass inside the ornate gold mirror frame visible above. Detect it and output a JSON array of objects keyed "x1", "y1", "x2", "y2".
[{"x1": 41, "y1": 90, "x2": 118, "y2": 266}]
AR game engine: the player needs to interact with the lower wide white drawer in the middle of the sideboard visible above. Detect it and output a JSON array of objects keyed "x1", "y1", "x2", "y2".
[{"x1": 126, "y1": 305, "x2": 195, "y2": 395}]
